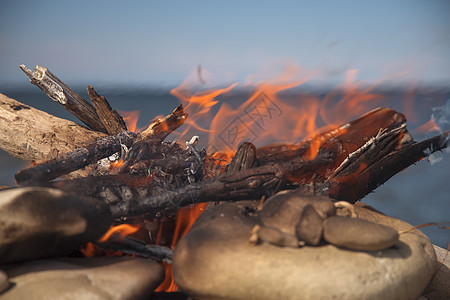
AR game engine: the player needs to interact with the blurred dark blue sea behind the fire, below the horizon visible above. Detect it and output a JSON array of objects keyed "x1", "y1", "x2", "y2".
[{"x1": 0, "y1": 84, "x2": 450, "y2": 248}]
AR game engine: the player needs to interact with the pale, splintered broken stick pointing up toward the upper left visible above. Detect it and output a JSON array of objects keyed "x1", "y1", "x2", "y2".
[{"x1": 20, "y1": 65, "x2": 108, "y2": 133}]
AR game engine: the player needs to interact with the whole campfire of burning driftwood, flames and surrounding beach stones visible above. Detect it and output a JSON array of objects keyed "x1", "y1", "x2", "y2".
[{"x1": 0, "y1": 65, "x2": 449, "y2": 299}]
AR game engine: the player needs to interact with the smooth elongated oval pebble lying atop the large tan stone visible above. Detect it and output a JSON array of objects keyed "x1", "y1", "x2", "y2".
[{"x1": 323, "y1": 216, "x2": 398, "y2": 251}]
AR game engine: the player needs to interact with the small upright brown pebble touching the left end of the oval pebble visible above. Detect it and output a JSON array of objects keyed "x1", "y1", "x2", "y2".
[{"x1": 295, "y1": 205, "x2": 323, "y2": 246}]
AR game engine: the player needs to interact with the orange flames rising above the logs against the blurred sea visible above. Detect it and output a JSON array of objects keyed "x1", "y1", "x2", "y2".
[{"x1": 171, "y1": 66, "x2": 432, "y2": 163}]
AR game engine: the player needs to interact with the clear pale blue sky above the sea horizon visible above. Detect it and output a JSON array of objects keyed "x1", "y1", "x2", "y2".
[{"x1": 0, "y1": 0, "x2": 450, "y2": 87}]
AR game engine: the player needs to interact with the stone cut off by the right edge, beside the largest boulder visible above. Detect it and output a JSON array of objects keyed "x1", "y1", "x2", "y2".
[{"x1": 423, "y1": 245, "x2": 450, "y2": 300}]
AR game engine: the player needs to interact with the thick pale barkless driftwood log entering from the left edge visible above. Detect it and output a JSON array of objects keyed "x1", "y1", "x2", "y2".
[{"x1": 0, "y1": 94, "x2": 106, "y2": 178}]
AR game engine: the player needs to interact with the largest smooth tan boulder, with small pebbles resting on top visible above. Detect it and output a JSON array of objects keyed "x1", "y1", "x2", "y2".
[{"x1": 172, "y1": 202, "x2": 436, "y2": 299}]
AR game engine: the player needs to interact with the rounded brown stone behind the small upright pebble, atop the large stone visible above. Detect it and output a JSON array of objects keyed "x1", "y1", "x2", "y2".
[{"x1": 259, "y1": 190, "x2": 336, "y2": 235}]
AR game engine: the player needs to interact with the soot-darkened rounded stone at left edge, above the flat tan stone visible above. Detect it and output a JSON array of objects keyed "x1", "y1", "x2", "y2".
[{"x1": 0, "y1": 187, "x2": 112, "y2": 263}]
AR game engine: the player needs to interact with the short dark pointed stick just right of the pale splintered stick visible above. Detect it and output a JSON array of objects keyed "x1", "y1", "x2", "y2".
[{"x1": 87, "y1": 85, "x2": 127, "y2": 135}]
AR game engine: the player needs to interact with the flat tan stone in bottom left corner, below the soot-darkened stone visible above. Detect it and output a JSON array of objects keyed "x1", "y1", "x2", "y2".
[{"x1": 0, "y1": 257, "x2": 164, "y2": 300}]
